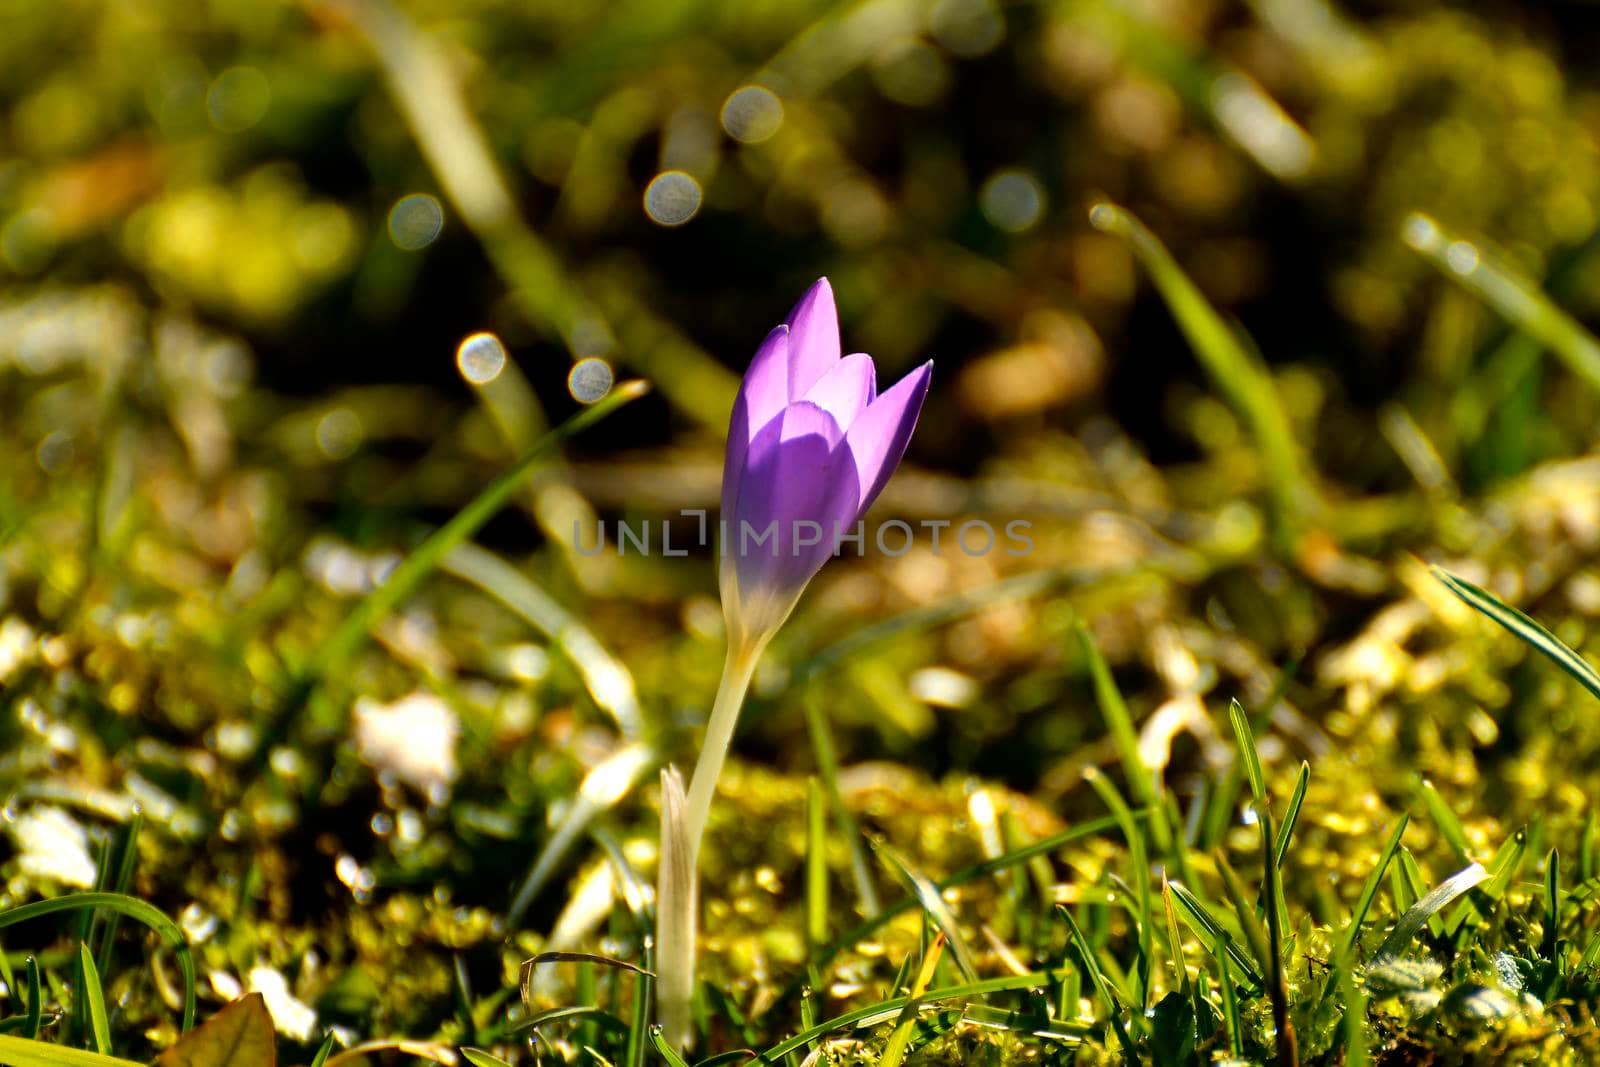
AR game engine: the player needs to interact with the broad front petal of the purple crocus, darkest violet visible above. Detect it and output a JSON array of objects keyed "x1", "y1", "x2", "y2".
[{"x1": 723, "y1": 402, "x2": 859, "y2": 617}]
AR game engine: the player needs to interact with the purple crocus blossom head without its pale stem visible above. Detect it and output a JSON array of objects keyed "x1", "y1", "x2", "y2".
[{"x1": 722, "y1": 278, "x2": 933, "y2": 641}]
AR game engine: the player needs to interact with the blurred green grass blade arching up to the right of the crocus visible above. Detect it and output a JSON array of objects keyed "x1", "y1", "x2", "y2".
[{"x1": 1090, "y1": 202, "x2": 1320, "y2": 530}]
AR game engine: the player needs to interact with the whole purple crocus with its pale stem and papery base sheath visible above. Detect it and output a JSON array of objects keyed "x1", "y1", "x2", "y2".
[{"x1": 656, "y1": 278, "x2": 933, "y2": 1048}]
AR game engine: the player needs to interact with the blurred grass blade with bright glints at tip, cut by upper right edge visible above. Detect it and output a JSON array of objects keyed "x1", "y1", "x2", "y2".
[{"x1": 1402, "y1": 213, "x2": 1600, "y2": 396}]
